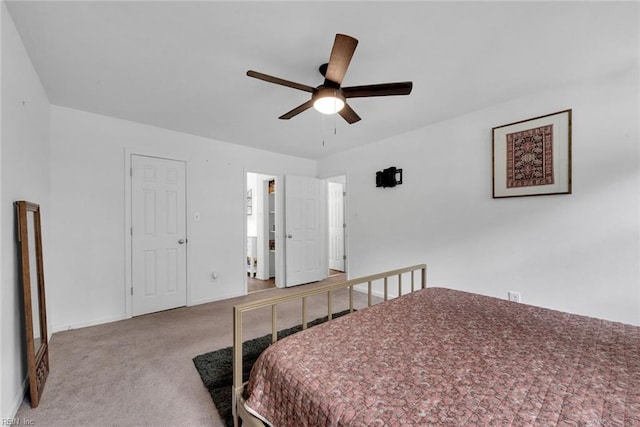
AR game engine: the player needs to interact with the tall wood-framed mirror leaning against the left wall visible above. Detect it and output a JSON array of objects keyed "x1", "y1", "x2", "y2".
[{"x1": 15, "y1": 200, "x2": 49, "y2": 408}]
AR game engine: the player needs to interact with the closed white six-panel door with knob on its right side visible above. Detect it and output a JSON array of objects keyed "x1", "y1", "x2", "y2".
[{"x1": 131, "y1": 155, "x2": 187, "y2": 316}]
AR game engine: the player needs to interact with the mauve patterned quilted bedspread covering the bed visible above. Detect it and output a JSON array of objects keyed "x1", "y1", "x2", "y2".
[{"x1": 246, "y1": 288, "x2": 640, "y2": 427}]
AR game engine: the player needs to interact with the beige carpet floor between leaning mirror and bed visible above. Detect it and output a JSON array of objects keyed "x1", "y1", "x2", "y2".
[{"x1": 16, "y1": 276, "x2": 366, "y2": 427}]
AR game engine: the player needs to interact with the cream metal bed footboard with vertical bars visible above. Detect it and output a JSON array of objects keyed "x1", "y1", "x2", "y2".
[{"x1": 232, "y1": 264, "x2": 427, "y2": 427}]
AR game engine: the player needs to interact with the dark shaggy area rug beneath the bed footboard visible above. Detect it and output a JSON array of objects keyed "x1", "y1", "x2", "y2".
[{"x1": 193, "y1": 310, "x2": 349, "y2": 427}]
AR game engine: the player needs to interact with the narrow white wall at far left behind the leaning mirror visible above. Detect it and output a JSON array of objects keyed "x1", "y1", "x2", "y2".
[{"x1": 0, "y1": 2, "x2": 51, "y2": 419}]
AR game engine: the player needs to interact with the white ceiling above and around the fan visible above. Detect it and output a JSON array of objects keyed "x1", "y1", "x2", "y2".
[{"x1": 6, "y1": 1, "x2": 638, "y2": 159}]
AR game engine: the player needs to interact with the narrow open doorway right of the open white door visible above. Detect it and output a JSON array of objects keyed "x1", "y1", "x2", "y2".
[{"x1": 327, "y1": 175, "x2": 347, "y2": 278}]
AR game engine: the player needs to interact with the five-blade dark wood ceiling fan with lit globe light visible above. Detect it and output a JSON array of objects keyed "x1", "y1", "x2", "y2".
[{"x1": 247, "y1": 34, "x2": 413, "y2": 124}]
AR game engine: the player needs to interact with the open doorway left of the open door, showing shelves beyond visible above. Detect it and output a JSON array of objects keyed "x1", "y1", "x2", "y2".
[{"x1": 246, "y1": 172, "x2": 278, "y2": 293}]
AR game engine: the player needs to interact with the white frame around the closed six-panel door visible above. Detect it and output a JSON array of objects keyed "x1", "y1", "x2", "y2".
[{"x1": 123, "y1": 148, "x2": 189, "y2": 319}]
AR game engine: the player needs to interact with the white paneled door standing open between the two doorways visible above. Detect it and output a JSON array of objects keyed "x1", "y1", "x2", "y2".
[{"x1": 284, "y1": 175, "x2": 326, "y2": 286}]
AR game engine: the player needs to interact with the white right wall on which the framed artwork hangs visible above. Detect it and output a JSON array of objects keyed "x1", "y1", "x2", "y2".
[{"x1": 318, "y1": 67, "x2": 640, "y2": 324}]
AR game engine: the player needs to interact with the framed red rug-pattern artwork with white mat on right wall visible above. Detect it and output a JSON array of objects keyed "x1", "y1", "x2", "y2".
[{"x1": 492, "y1": 110, "x2": 571, "y2": 199}]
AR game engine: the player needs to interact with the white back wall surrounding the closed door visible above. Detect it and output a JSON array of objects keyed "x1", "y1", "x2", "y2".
[{"x1": 47, "y1": 106, "x2": 315, "y2": 330}]
